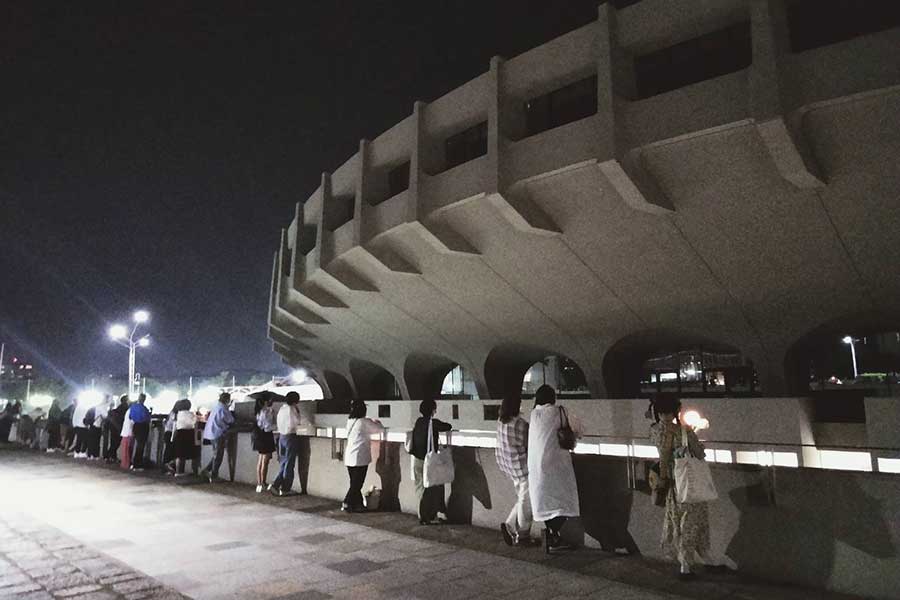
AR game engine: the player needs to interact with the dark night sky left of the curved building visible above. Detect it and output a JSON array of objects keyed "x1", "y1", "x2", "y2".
[{"x1": 0, "y1": 0, "x2": 597, "y2": 381}]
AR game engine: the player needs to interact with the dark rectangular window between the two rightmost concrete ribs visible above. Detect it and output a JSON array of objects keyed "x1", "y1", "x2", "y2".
[{"x1": 634, "y1": 21, "x2": 753, "y2": 98}]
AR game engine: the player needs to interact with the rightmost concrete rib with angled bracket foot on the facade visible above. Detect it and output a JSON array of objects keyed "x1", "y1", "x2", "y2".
[{"x1": 749, "y1": 0, "x2": 825, "y2": 189}]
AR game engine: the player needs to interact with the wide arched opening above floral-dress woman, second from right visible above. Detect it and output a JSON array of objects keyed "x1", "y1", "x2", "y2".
[{"x1": 603, "y1": 330, "x2": 759, "y2": 398}]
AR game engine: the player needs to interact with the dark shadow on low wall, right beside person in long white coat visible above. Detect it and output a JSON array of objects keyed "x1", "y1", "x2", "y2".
[{"x1": 574, "y1": 455, "x2": 640, "y2": 553}]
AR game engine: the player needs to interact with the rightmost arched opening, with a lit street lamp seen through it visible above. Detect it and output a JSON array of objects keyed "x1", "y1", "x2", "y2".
[{"x1": 784, "y1": 312, "x2": 900, "y2": 396}]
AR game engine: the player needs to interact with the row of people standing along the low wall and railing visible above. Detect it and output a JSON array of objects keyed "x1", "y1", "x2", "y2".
[{"x1": 0, "y1": 385, "x2": 709, "y2": 579}]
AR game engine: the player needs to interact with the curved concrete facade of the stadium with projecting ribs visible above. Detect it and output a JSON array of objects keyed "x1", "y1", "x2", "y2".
[{"x1": 269, "y1": 0, "x2": 900, "y2": 399}]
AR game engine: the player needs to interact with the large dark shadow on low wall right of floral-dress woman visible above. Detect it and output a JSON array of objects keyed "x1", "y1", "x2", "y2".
[{"x1": 726, "y1": 472, "x2": 900, "y2": 587}]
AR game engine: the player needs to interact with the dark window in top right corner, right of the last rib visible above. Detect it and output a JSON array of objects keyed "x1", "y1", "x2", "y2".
[{"x1": 787, "y1": 0, "x2": 900, "y2": 52}]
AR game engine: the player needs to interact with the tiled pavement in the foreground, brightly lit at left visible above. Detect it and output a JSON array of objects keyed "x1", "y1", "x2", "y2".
[{"x1": 0, "y1": 447, "x2": 847, "y2": 600}]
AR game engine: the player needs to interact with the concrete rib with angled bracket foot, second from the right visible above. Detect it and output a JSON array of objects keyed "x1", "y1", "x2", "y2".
[{"x1": 597, "y1": 2, "x2": 674, "y2": 215}]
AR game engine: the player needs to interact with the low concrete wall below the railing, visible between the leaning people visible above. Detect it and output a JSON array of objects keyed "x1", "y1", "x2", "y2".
[{"x1": 193, "y1": 434, "x2": 900, "y2": 598}]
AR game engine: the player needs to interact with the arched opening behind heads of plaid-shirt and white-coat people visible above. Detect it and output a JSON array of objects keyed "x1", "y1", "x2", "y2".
[{"x1": 484, "y1": 344, "x2": 590, "y2": 398}]
